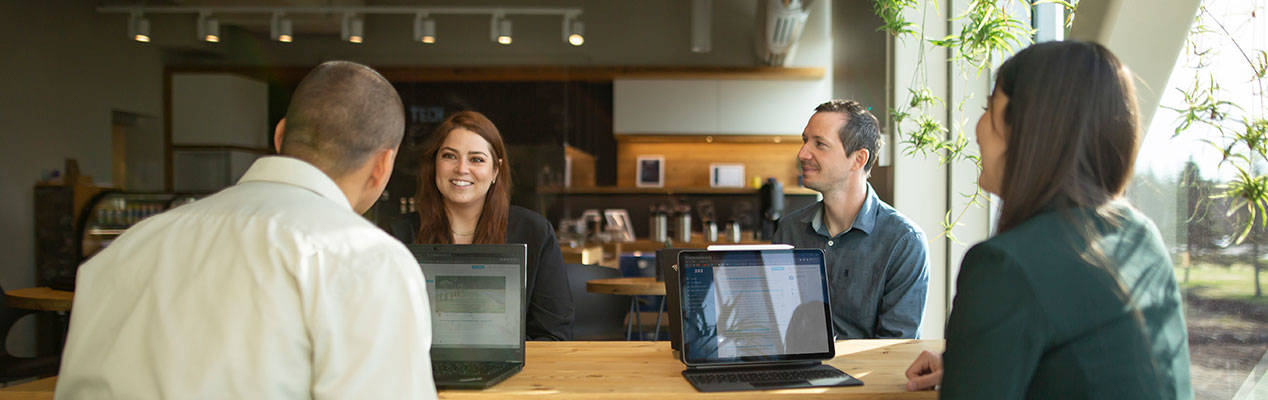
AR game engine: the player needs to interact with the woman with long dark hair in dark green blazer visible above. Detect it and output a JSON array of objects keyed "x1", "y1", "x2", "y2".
[{"x1": 907, "y1": 42, "x2": 1193, "y2": 399}]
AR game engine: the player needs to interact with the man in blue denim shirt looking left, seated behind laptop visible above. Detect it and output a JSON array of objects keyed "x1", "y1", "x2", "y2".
[{"x1": 772, "y1": 100, "x2": 929, "y2": 339}]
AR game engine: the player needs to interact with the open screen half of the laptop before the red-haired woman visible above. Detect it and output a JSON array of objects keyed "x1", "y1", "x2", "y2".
[{"x1": 410, "y1": 245, "x2": 525, "y2": 358}]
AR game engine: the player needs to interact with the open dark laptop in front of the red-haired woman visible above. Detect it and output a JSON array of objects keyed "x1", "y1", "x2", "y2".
[{"x1": 408, "y1": 244, "x2": 527, "y2": 389}]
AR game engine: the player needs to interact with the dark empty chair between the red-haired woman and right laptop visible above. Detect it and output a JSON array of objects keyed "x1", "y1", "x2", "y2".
[{"x1": 567, "y1": 264, "x2": 630, "y2": 340}]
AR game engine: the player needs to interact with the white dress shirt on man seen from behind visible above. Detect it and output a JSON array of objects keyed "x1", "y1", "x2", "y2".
[{"x1": 56, "y1": 156, "x2": 436, "y2": 399}]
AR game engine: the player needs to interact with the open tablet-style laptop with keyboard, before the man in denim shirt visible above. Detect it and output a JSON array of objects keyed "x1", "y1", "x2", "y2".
[{"x1": 678, "y1": 249, "x2": 862, "y2": 392}]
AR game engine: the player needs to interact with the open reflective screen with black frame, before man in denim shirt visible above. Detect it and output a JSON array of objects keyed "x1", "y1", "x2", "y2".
[{"x1": 678, "y1": 249, "x2": 834, "y2": 366}]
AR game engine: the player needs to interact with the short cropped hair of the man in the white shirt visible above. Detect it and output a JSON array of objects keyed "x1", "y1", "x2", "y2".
[{"x1": 278, "y1": 61, "x2": 404, "y2": 178}]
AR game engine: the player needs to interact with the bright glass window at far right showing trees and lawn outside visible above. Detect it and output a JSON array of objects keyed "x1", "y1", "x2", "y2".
[{"x1": 1127, "y1": 0, "x2": 1268, "y2": 399}]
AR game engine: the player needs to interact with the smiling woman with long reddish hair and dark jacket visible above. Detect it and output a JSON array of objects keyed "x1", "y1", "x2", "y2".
[{"x1": 392, "y1": 110, "x2": 573, "y2": 340}]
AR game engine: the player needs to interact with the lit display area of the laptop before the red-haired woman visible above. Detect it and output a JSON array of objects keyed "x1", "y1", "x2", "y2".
[{"x1": 421, "y1": 263, "x2": 521, "y2": 348}]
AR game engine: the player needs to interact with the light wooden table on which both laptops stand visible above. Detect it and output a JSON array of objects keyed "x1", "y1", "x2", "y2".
[{"x1": 0, "y1": 340, "x2": 943, "y2": 400}]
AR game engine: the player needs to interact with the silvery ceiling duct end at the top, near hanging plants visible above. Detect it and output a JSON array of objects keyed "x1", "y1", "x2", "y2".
[{"x1": 753, "y1": 0, "x2": 813, "y2": 66}]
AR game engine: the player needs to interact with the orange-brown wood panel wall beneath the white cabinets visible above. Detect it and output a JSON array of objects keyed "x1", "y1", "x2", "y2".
[{"x1": 616, "y1": 135, "x2": 801, "y2": 188}]
